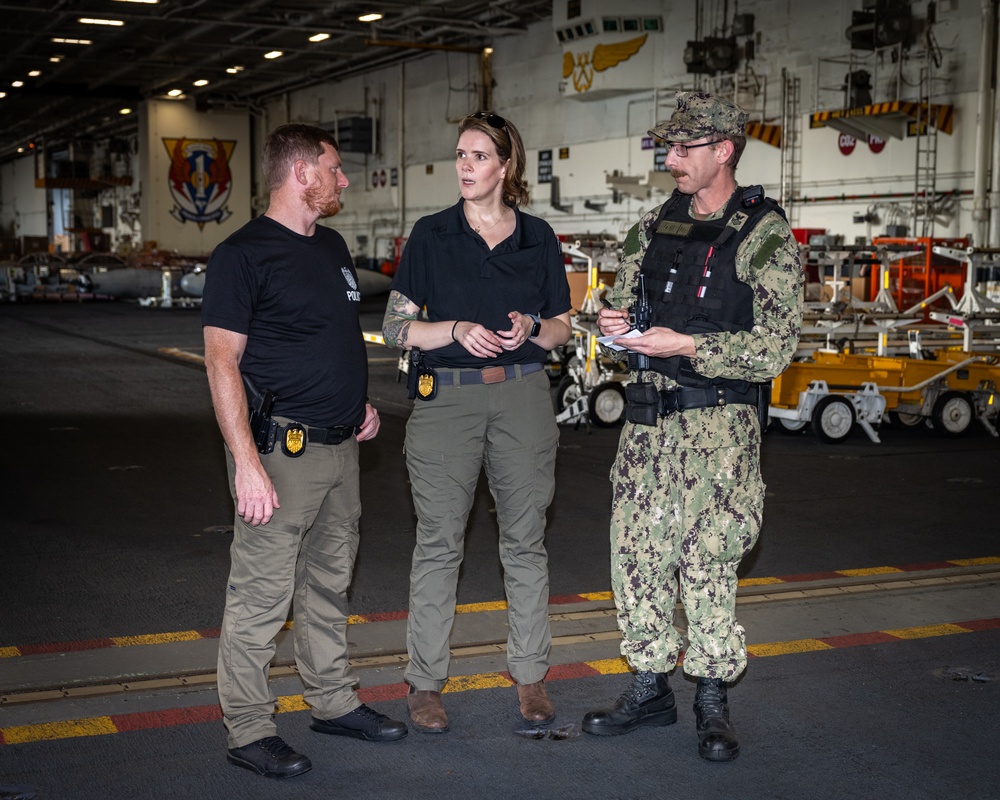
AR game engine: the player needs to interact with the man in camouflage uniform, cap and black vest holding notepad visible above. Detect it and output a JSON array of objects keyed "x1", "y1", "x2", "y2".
[{"x1": 583, "y1": 92, "x2": 802, "y2": 761}]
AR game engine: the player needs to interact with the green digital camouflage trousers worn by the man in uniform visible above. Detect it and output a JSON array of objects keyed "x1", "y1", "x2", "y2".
[{"x1": 611, "y1": 423, "x2": 764, "y2": 681}]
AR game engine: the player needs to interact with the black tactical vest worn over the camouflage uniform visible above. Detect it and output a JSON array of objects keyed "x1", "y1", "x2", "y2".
[{"x1": 640, "y1": 186, "x2": 784, "y2": 391}]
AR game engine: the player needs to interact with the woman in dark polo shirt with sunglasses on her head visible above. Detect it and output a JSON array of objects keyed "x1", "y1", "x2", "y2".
[{"x1": 382, "y1": 112, "x2": 570, "y2": 733}]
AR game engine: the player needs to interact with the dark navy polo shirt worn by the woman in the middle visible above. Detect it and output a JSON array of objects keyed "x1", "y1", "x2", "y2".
[{"x1": 392, "y1": 200, "x2": 572, "y2": 368}]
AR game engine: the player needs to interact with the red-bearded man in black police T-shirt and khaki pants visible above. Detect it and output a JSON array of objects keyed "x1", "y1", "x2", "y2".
[{"x1": 202, "y1": 124, "x2": 407, "y2": 778}]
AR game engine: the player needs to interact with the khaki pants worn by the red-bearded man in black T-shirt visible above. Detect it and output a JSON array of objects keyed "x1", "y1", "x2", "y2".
[{"x1": 219, "y1": 437, "x2": 361, "y2": 748}]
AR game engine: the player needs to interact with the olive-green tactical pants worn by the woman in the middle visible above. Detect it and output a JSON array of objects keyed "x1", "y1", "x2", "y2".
[{"x1": 406, "y1": 371, "x2": 559, "y2": 691}]
